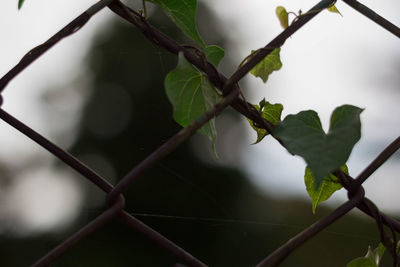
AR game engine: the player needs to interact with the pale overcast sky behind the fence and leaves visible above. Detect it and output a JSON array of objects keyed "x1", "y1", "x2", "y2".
[{"x1": 0, "y1": 0, "x2": 400, "y2": 234}]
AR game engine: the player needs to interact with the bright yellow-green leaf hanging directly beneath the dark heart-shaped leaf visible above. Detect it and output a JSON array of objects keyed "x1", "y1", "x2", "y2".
[{"x1": 304, "y1": 165, "x2": 349, "y2": 214}]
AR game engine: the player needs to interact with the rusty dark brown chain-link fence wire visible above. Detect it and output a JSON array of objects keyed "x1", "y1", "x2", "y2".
[{"x1": 0, "y1": 0, "x2": 400, "y2": 266}]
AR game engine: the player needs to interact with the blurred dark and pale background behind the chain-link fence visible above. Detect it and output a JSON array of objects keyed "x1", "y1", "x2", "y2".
[{"x1": 0, "y1": 0, "x2": 400, "y2": 266}]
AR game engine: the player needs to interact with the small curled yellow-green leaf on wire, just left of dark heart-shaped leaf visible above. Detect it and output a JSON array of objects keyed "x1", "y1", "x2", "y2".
[{"x1": 247, "y1": 100, "x2": 283, "y2": 144}]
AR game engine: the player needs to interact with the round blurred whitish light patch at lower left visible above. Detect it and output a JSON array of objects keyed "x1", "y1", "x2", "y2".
[{"x1": 1, "y1": 168, "x2": 83, "y2": 235}]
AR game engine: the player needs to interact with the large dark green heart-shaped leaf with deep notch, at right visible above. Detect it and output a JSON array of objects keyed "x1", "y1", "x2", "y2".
[{"x1": 274, "y1": 105, "x2": 363, "y2": 188}]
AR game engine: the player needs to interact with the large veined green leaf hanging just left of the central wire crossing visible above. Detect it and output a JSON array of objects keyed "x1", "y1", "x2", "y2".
[{"x1": 165, "y1": 46, "x2": 224, "y2": 151}]
